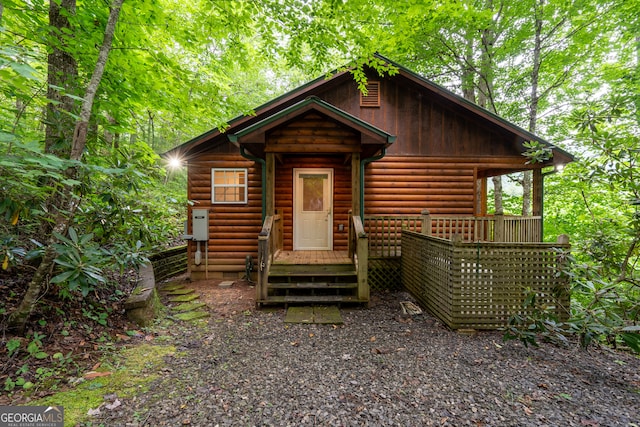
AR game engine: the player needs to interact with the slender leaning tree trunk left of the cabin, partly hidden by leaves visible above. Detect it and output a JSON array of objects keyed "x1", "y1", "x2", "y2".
[{"x1": 8, "y1": 0, "x2": 123, "y2": 334}]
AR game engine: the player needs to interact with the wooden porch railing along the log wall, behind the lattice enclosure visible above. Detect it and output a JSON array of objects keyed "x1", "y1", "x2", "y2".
[{"x1": 363, "y1": 211, "x2": 542, "y2": 257}]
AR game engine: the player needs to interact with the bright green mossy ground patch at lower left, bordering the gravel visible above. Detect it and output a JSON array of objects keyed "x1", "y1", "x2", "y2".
[{"x1": 30, "y1": 343, "x2": 176, "y2": 426}]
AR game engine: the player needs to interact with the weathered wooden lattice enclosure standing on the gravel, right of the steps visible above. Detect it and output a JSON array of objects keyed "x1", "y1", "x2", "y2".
[{"x1": 401, "y1": 231, "x2": 570, "y2": 329}]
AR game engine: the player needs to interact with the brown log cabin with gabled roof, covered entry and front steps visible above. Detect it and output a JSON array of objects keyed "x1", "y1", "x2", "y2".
[{"x1": 164, "y1": 55, "x2": 572, "y2": 312}]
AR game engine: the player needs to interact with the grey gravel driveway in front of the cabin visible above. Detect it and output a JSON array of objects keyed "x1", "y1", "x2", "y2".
[{"x1": 95, "y1": 293, "x2": 640, "y2": 426}]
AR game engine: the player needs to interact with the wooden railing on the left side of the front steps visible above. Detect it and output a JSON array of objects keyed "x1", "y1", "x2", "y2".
[{"x1": 256, "y1": 213, "x2": 283, "y2": 301}]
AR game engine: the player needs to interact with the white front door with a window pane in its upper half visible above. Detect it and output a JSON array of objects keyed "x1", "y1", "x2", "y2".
[{"x1": 293, "y1": 169, "x2": 333, "y2": 250}]
